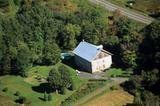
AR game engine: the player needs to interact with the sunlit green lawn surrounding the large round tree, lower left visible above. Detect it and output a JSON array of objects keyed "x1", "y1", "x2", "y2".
[{"x1": 0, "y1": 63, "x2": 87, "y2": 106}]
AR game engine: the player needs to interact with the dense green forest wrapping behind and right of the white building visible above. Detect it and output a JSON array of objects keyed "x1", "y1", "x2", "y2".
[{"x1": 0, "y1": 0, "x2": 160, "y2": 106}]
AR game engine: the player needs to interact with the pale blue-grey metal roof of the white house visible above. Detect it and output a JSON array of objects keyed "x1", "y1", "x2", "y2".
[{"x1": 73, "y1": 41, "x2": 103, "y2": 61}]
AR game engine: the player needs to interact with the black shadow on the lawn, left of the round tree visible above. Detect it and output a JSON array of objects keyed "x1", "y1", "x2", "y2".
[{"x1": 32, "y1": 83, "x2": 55, "y2": 93}]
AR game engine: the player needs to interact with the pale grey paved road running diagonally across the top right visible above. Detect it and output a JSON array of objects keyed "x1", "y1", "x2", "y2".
[{"x1": 90, "y1": 0, "x2": 154, "y2": 24}]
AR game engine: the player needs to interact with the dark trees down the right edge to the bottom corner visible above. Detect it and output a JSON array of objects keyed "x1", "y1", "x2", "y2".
[{"x1": 123, "y1": 21, "x2": 160, "y2": 106}]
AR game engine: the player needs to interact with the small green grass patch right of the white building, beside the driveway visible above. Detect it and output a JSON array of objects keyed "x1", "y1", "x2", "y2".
[{"x1": 104, "y1": 68, "x2": 132, "y2": 77}]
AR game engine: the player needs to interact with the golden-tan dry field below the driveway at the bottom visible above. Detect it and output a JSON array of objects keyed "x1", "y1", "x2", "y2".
[{"x1": 83, "y1": 90, "x2": 134, "y2": 106}]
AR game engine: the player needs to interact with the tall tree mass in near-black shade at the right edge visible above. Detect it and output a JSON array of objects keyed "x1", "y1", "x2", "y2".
[{"x1": 139, "y1": 21, "x2": 160, "y2": 70}]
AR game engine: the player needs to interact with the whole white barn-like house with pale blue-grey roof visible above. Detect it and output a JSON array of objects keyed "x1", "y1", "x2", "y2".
[{"x1": 73, "y1": 41, "x2": 112, "y2": 73}]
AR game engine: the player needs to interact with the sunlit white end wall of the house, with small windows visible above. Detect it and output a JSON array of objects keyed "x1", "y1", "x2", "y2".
[{"x1": 91, "y1": 55, "x2": 112, "y2": 73}]
